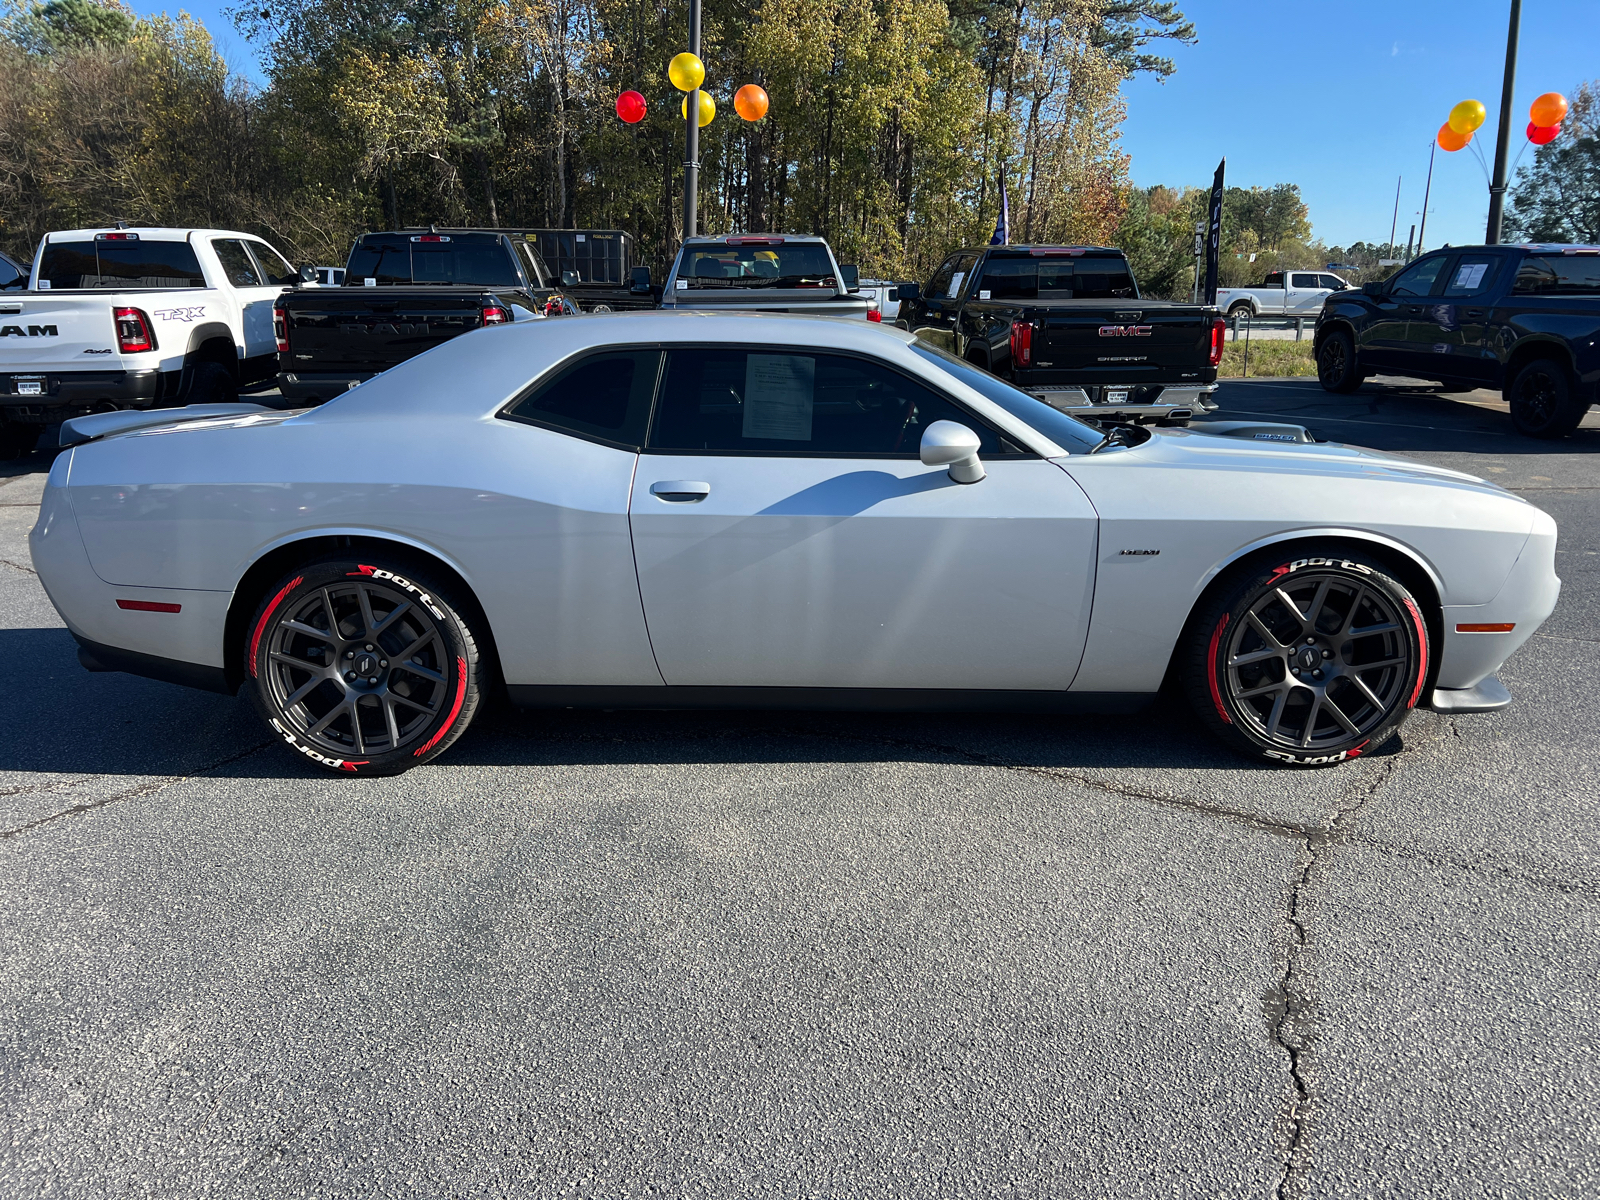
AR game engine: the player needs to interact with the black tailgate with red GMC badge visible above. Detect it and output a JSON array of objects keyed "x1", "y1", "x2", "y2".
[{"x1": 1034, "y1": 304, "x2": 1211, "y2": 382}]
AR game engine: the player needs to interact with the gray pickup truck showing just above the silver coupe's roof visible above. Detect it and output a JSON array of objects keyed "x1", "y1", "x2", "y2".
[{"x1": 661, "y1": 234, "x2": 870, "y2": 318}]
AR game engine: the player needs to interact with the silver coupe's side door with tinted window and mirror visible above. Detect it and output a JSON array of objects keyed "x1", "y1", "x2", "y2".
[{"x1": 629, "y1": 346, "x2": 1096, "y2": 690}]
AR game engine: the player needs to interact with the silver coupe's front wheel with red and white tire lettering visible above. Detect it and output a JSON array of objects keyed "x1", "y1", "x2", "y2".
[{"x1": 1181, "y1": 546, "x2": 1429, "y2": 766}]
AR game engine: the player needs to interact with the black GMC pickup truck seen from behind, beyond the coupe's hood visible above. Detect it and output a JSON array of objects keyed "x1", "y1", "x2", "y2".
[{"x1": 896, "y1": 246, "x2": 1224, "y2": 424}]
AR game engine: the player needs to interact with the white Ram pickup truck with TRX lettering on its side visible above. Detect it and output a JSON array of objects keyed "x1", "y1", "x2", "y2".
[{"x1": 0, "y1": 229, "x2": 299, "y2": 458}]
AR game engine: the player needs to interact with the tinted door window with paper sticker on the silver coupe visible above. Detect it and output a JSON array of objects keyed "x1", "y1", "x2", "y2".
[{"x1": 650, "y1": 349, "x2": 1003, "y2": 458}]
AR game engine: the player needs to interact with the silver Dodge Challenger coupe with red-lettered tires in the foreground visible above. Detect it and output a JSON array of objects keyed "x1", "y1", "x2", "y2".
[{"x1": 30, "y1": 312, "x2": 1560, "y2": 774}]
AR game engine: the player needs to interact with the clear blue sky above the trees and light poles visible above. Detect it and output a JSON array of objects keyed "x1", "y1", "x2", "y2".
[{"x1": 134, "y1": 0, "x2": 1600, "y2": 246}]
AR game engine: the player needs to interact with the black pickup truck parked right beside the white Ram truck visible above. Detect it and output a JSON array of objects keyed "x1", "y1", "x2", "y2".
[{"x1": 272, "y1": 229, "x2": 578, "y2": 403}]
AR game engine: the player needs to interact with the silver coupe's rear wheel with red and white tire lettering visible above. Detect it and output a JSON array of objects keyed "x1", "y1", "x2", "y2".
[{"x1": 245, "y1": 557, "x2": 485, "y2": 774}]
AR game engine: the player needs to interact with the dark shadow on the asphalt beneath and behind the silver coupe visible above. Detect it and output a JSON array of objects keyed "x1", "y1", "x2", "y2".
[{"x1": 0, "y1": 629, "x2": 1400, "y2": 779}]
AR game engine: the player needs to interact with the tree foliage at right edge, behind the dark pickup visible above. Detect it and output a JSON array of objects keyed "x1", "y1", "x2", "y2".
[{"x1": 1506, "y1": 82, "x2": 1600, "y2": 245}]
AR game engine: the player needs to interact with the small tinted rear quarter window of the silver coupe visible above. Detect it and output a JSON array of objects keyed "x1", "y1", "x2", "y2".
[{"x1": 501, "y1": 350, "x2": 661, "y2": 446}]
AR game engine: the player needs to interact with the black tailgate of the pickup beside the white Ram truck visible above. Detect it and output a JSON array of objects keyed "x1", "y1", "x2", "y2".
[{"x1": 283, "y1": 288, "x2": 483, "y2": 371}]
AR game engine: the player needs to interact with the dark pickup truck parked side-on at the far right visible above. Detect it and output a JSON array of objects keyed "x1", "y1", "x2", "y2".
[{"x1": 1315, "y1": 245, "x2": 1600, "y2": 438}]
